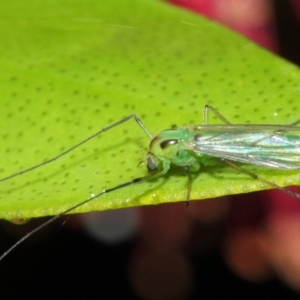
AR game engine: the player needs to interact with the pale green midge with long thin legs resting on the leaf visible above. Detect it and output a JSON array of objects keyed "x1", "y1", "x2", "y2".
[{"x1": 0, "y1": 105, "x2": 300, "y2": 261}]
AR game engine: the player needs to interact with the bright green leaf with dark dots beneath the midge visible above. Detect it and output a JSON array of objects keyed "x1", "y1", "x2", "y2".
[{"x1": 0, "y1": 0, "x2": 300, "y2": 219}]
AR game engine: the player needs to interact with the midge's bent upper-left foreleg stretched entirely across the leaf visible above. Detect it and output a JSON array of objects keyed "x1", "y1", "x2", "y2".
[{"x1": 0, "y1": 114, "x2": 152, "y2": 182}]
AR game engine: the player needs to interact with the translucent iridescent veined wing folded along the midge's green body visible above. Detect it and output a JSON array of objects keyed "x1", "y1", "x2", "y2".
[{"x1": 185, "y1": 125, "x2": 300, "y2": 169}]
